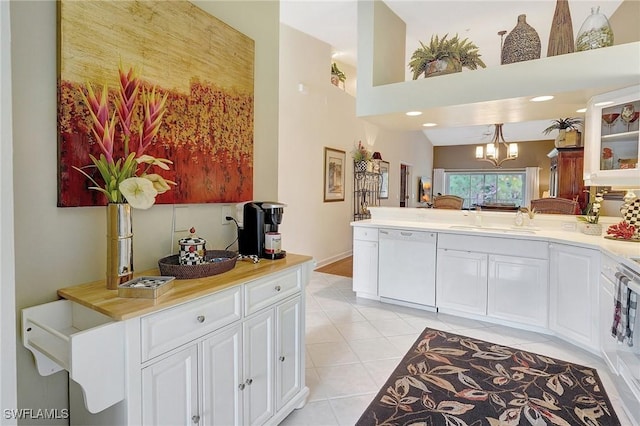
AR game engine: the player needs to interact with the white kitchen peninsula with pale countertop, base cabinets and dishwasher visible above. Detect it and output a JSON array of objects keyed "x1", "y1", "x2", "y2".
[{"x1": 351, "y1": 207, "x2": 640, "y2": 421}]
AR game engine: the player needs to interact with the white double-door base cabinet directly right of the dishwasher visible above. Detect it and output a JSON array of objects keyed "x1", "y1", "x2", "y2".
[{"x1": 436, "y1": 234, "x2": 549, "y2": 329}]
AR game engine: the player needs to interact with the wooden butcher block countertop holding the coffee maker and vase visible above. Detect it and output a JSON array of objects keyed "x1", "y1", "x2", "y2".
[{"x1": 58, "y1": 253, "x2": 312, "y2": 320}]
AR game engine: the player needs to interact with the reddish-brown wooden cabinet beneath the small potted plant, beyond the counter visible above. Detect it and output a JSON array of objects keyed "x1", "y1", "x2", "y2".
[{"x1": 548, "y1": 148, "x2": 589, "y2": 211}]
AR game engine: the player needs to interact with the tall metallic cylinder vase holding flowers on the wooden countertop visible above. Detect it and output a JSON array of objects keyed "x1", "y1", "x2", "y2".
[{"x1": 107, "y1": 203, "x2": 133, "y2": 290}]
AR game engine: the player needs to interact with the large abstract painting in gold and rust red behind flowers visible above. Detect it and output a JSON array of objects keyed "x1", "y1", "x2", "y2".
[{"x1": 58, "y1": 0, "x2": 254, "y2": 207}]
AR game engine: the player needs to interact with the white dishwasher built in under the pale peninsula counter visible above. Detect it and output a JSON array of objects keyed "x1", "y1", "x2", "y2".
[{"x1": 378, "y1": 229, "x2": 438, "y2": 307}]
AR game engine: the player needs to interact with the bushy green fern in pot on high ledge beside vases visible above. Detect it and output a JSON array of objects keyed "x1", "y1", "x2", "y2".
[{"x1": 409, "y1": 34, "x2": 486, "y2": 80}]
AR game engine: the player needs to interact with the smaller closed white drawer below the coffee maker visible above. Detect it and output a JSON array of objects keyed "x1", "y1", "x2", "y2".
[{"x1": 244, "y1": 268, "x2": 301, "y2": 315}]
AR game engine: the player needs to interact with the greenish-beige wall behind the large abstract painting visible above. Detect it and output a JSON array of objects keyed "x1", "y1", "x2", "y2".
[{"x1": 10, "y1": 1, "x2": 279, "y2": 418}]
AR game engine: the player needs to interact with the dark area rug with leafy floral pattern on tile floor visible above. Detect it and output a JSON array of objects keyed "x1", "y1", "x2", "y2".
[{"x1": 357, "y1": 328, "x2": 620, "y2": 426}]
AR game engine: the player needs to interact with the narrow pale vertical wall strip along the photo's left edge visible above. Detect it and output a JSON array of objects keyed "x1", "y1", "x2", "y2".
[{"x1": 0, "y1": 2, "x2": 18, "y2": 425}]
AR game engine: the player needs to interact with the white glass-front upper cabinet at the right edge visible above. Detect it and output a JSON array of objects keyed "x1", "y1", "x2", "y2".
[{"x1": 584, "y1": 85, "x2": 640, "y2": 188}]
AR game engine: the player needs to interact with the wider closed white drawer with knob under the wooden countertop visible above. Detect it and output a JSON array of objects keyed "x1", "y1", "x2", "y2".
[{"x1": 141, "y1": 286, "x2": 242, "y2": 361}]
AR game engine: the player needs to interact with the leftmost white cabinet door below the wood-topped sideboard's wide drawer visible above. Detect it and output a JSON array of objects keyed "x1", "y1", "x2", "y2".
[{"x1": 142, "y1": 345, "x2": 199, "y2": 426}]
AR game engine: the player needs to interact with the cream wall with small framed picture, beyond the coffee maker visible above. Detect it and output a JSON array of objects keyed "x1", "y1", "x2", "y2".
[{"x1": 278, "y1": 25, "x2": 433, "y2": 264}]
